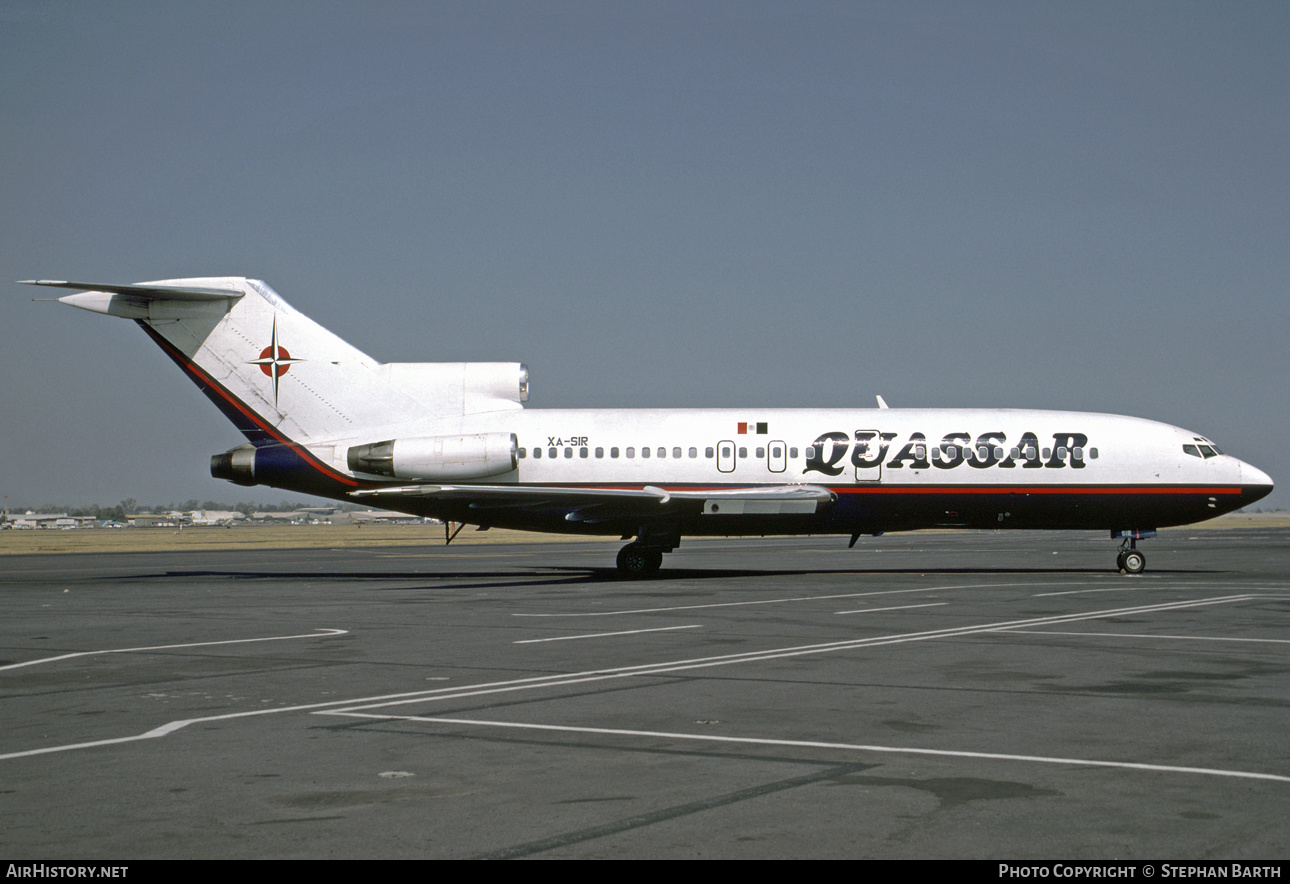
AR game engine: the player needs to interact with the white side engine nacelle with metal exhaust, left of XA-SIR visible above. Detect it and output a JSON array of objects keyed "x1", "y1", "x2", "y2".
[{"x1": 347, "y1": 432, "x2": 519, "y2": 481}]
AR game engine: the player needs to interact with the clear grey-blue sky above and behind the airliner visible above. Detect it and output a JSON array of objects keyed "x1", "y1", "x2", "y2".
[{"x1": 0, "y1": 0, "x2": 1290, "y2": 506}]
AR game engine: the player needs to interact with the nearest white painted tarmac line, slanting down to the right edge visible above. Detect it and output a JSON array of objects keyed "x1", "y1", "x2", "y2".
[{"x1": 319, "y1": 710, "x2": 1290, "y2": 783}]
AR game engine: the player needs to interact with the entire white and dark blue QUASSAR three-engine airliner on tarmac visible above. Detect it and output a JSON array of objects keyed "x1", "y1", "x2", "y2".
[{"x1": 25, "y1": 276, "x2": 1272, "y2": 576}]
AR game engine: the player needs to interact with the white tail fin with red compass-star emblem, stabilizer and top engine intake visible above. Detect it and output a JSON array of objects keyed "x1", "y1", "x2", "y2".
[{"x1": 26, "y1": 276, "x2": 528, "y2": 445}]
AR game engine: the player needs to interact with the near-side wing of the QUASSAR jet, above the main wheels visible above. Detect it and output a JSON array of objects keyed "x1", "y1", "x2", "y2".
[{"x1": 350, "y1": 485, "x2": 837, "y2": 521}]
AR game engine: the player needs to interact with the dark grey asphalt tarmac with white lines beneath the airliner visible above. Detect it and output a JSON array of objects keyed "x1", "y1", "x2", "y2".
[{"x1": 0, "y1": 528, "x2": 1290, "y2": 861}]
